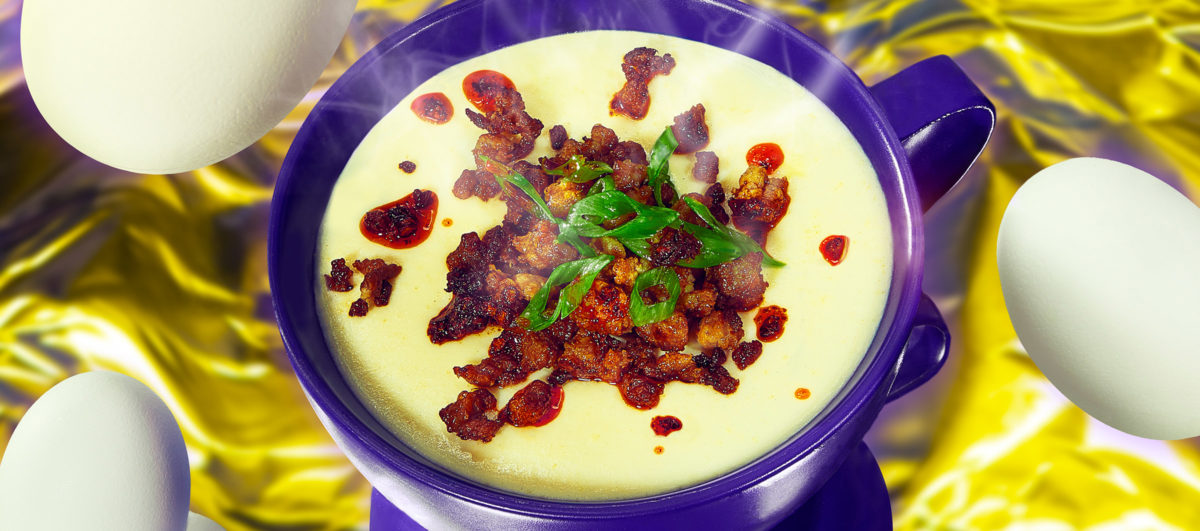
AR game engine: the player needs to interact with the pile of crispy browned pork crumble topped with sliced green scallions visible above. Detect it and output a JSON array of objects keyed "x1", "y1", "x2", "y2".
[{"x1": 427, "y1": 48, "x2": 790, "y2": 442}]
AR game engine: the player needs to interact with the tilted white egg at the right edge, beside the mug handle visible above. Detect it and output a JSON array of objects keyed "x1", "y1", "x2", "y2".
[{"x1": 996, "y1": 159, "x2": 1200, "y2": 440}]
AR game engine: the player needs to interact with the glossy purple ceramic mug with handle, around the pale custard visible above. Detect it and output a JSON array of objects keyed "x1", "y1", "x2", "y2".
[{"x1": 268, "y1": 0, "x2": 995, "y2": 530}]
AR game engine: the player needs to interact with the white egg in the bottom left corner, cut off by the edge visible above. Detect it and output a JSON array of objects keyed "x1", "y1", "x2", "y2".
[{"x1": 0, "y1": 371, "x2": 191, "y2": 531}]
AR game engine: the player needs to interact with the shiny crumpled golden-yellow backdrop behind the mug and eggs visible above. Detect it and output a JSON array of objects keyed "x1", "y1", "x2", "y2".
[{"x1": 0, "y1": 0, "x2": 1200, "y2": 531}]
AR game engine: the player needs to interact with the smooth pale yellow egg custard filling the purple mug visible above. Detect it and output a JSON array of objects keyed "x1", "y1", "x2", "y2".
[{"x1": 314, "y1": 31, "x2": 892, "y2": 500}]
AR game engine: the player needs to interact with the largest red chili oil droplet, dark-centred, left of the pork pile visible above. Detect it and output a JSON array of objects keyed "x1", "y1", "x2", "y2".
[{"x1": 359, "y1": 190, "x2": 438, "y2": 249}]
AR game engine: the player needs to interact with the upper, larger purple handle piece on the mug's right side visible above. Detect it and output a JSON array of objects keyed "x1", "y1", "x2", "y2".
[{"x1": 870, "y1": 55, "x2": 996, "y2": 211}]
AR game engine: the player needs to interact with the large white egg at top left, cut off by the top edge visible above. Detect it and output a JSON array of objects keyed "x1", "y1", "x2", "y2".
[{"x1": 20, "y1": 0, "x2": 355, "y2": 173}]
